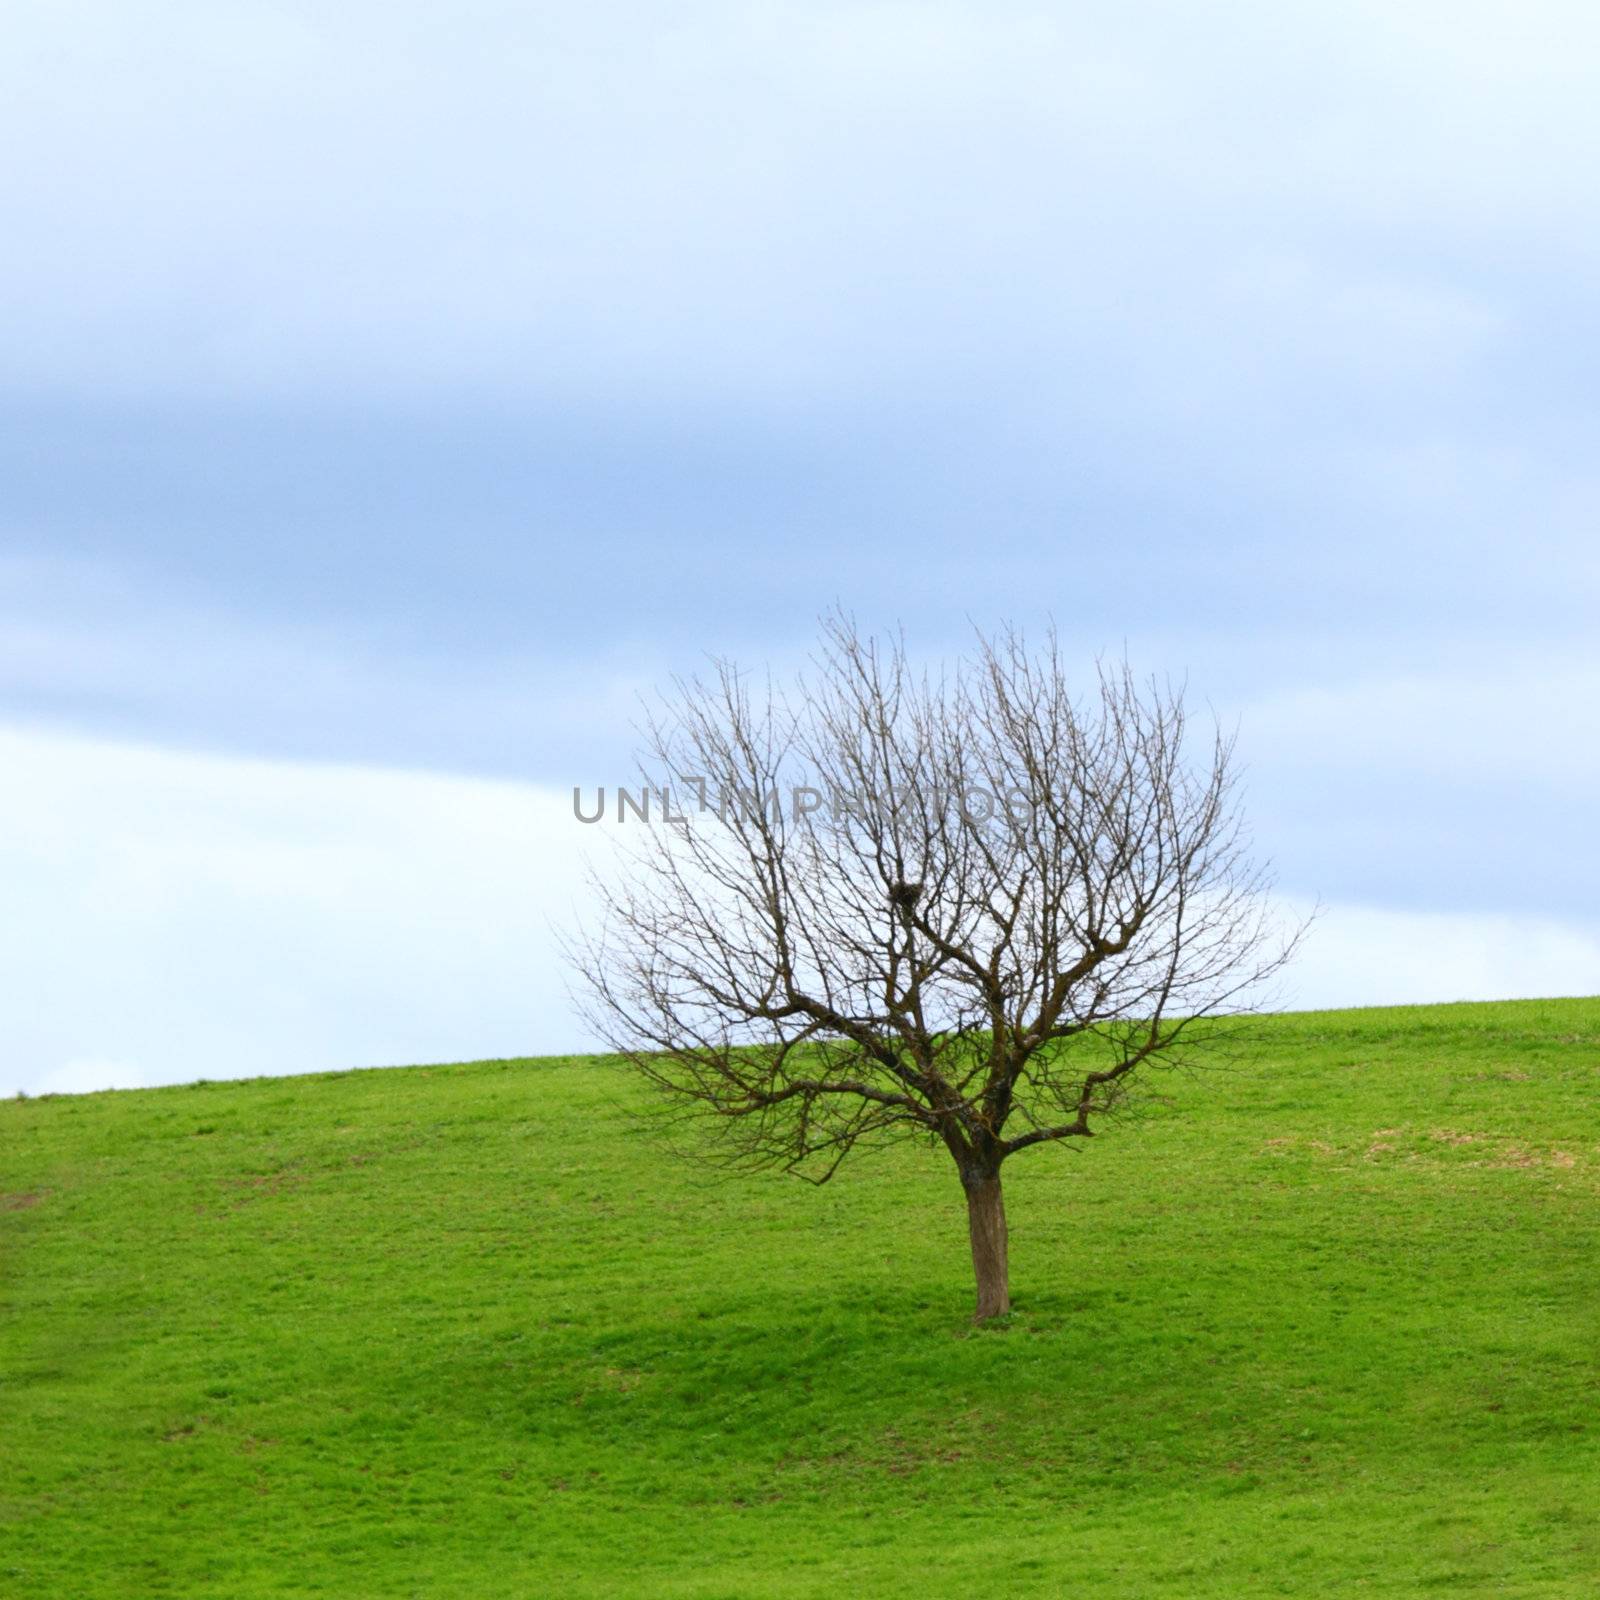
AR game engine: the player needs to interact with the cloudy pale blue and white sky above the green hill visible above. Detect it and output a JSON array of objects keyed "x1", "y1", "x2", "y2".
[{"x1": 0, "y1": 0, "x2": 1600, "y2": 1093}]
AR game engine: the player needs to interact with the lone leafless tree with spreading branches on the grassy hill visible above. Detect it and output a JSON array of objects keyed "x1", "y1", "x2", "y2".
[{"x1": 571, "y1": 618, "x2": 1294, "y2": 1320}]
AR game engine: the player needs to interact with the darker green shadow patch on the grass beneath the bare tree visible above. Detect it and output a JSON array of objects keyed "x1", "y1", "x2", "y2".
[{"x1": 368, "y1": 1267, "x2": 1331, "y2": 1498}]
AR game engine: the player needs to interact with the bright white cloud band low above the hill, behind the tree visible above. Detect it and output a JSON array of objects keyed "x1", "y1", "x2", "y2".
[{"x1": 0, "y1": 728, "x2": 1600, "y2": 1093}]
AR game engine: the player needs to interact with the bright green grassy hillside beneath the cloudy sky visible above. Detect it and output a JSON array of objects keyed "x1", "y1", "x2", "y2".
[{"x1": 0, "y1": 1000, "x2": 1600, "y2": 1600}]
